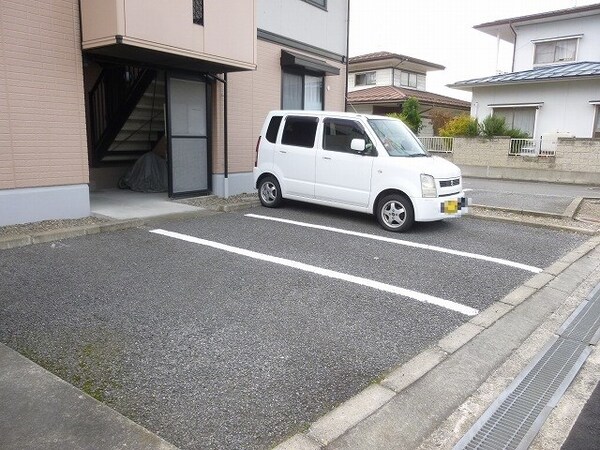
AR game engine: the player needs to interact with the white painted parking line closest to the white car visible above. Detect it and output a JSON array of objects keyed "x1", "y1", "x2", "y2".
[{"x1": 246, "y1": 214, "x2": 544, "y2": 273}]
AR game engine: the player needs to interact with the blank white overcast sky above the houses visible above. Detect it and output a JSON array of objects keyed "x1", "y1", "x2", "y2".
[{"x1": 349, "y1": 0, "x2": 600, "y2": 100}]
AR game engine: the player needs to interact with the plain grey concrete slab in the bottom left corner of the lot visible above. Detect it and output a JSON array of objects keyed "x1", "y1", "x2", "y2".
[{"x1": 0, "y1": 344, "x2": 175, "y2": 450}]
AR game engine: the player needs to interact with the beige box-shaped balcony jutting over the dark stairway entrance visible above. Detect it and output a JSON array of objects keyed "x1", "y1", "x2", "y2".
[{"x1": 81, "y1": 0, "x2": 256, "y2": 73}]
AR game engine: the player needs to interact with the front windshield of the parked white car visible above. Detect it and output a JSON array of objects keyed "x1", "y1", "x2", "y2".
[{"x1": 369, "y1": 119, "x2": 430, "y2": 157}]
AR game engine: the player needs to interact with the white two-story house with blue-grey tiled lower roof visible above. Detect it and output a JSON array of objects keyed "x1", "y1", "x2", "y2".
[{"x1": 450, "y1": 4, "x2": 600, "y2": 145}]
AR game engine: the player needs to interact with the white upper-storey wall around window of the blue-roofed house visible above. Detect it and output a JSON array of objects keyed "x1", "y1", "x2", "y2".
[{"x1": 513, "y1": 15, "x2": 600, "y2": 72}]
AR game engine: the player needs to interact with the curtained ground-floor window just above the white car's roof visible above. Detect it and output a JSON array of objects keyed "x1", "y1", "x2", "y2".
[{"x1": 281, "y1": 72, "x2": 324, "y2": 111}]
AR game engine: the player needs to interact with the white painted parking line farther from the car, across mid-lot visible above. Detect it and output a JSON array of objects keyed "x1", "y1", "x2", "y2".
[{"x1": 150, "y1": 229, "x2": 479, "y2": 316}]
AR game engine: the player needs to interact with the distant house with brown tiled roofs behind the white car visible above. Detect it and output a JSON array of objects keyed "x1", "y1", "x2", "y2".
[{"x1": 346, "y1": 52, "x2": 470, "y2": 136}]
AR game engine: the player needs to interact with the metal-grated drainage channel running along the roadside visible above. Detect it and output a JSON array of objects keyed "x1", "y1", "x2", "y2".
[{"x1": 454, "y1": 284, "x2": 600, "y2": 450}]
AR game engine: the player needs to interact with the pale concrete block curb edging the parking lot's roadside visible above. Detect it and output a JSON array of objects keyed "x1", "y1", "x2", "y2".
[{"x1": 275, "y1": 236, "x2": 600, "y2": 450}]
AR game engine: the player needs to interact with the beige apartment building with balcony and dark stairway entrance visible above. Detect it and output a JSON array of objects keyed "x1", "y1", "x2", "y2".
[{"x1": 0, "y1": 0, "x2": 348, "y2": 226}]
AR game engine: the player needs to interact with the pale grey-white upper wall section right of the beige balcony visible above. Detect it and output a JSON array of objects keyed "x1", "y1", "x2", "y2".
[{"x1": 257, "y1": 0, "x2": 348, "y2": 55}]
